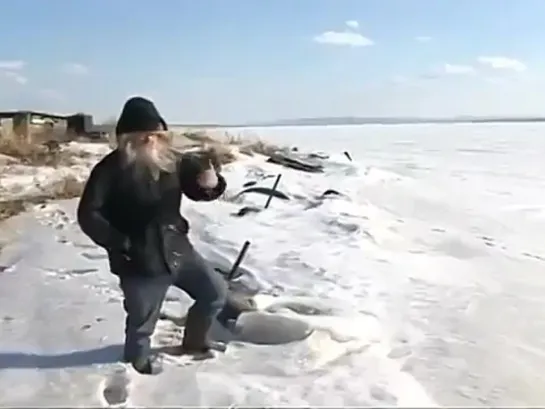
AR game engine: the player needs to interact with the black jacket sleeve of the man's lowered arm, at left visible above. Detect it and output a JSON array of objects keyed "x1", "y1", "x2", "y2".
[{"x1": 77, "y1": 159, "x2": 128, "y2": 252}]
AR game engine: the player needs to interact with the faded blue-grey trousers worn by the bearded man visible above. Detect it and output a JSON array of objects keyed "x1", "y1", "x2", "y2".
[{"x1": 120, "y1": 252, "x2": 227, "y2": 360}]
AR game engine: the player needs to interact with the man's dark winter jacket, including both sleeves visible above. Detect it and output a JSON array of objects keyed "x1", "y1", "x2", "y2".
[{"x1": 77, "y1": 151, "x2": 226, "y2": 276}]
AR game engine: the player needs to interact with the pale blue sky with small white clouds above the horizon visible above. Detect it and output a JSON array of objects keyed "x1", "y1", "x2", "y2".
[{"x1": 0, "y1": 0, "x2": 545, "y2": 122}]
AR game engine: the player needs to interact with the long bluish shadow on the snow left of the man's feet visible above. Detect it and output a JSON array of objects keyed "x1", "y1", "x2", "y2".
[{"x1": 0, "y1": 344, "x2": 123, "y2": 370}]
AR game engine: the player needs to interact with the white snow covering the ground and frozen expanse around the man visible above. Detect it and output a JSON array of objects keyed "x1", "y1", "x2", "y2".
[{"x1": 0, "y1": 124, "x2": 545, "y2": 407}]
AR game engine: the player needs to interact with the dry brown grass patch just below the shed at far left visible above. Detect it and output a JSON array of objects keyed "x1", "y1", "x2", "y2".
[{"x1": 0, "y1": 129, "x2": 90, "y2": 167}]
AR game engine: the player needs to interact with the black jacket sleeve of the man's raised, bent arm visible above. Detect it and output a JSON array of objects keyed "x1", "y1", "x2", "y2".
[{"x1": 178, "y1": 154, "x2": 227, "y2": 202}]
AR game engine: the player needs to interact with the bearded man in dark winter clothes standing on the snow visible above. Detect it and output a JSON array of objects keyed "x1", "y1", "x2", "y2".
[{"x1": 77, "y1": 97, "x2": 227, "y2": 374}]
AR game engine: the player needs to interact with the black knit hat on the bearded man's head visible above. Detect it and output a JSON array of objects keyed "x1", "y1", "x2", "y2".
[{"x1": 115, "y1": 97, "x2": 168, "y2": 135}]
